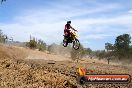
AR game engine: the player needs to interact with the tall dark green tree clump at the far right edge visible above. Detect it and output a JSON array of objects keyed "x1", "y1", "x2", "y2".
[{"x1": 105, "y1": 34, "x2": 132, "y2": 60}]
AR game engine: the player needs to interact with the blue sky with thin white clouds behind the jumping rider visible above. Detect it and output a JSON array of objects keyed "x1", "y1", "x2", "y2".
[{"x1": 0, "y1": 0, "x2": 132, "y2": 50}]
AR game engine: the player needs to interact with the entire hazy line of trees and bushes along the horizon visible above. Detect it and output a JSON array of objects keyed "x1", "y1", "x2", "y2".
[{"x1": 0, "y1": 30, "x2": 132, "y2": 60}]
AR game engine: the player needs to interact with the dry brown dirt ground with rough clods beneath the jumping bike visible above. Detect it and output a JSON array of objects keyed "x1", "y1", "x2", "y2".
[{"x1": 0, "y1": 45, "x2": 132, "y2": 88}]
